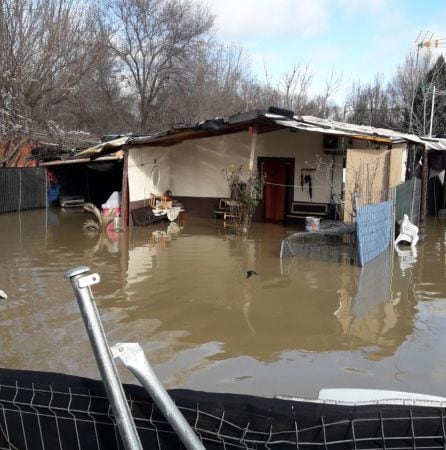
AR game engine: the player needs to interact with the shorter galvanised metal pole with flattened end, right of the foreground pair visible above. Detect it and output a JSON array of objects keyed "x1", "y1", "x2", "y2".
[{"x1": 111, "y1": 342, "x2": 205, "y2": 450}]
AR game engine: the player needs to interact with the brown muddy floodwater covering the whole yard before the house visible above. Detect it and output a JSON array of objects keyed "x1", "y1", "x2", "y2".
[{"x1": 0, "y1": 209, "x2": 446, "y2": 397}]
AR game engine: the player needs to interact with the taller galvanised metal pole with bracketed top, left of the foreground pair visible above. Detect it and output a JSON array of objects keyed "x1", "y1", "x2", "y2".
[{"x1": 65, "y1": 266, "x2": 142, "y2": 450}]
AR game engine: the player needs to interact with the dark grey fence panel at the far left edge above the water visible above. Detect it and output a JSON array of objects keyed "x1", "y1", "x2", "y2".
[{"x1": 0, "y1": 167, "x2": 47, "y2": 213}]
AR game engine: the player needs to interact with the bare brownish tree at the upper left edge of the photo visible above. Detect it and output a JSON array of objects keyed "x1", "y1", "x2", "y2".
[{"x1": 0, "y1": 0, "x2": 105, "y2": 164}]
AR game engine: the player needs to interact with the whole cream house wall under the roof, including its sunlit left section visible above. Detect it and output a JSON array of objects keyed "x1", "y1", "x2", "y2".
[{"x1": 129, "y1": 129, "x2": 342, "y2": 203}]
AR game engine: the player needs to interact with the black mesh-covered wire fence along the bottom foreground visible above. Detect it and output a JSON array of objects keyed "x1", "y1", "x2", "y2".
[{"x1": 0, "y1": 369, "x2": 446, "y2": 450}]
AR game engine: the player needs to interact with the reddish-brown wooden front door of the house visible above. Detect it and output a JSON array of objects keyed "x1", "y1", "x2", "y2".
[{"x1": 259, "y1": 158, "x2": 291, "y2": 221}]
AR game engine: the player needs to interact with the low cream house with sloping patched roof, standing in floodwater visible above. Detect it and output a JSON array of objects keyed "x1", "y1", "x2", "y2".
[{"x1": 41, "y1": 108, "x2": 443, "y2": 225}]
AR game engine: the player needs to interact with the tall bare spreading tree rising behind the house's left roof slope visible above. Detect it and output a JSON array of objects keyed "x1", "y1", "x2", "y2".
[{"x1": 103, "y1": 0, "x2": 213, "y2": 132}]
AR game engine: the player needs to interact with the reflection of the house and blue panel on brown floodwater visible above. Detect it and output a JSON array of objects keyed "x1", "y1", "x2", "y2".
[{"x1": 126, "y1": 225, "x2": 412, "y2": 362}]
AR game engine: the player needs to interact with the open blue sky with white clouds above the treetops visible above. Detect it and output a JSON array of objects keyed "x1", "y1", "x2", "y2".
[{"x1": 204, "y1": 0, "x2": 446, "y2": 101}]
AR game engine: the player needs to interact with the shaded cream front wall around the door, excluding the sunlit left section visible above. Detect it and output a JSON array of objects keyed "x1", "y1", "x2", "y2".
[{"x1": 171, "y1": 130, "x2": 342, "y2": 203}]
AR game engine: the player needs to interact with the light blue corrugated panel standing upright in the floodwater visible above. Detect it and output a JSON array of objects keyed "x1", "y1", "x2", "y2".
[{"x1": 356, "y1": 200, "x2": 393, "y2": 266}]
